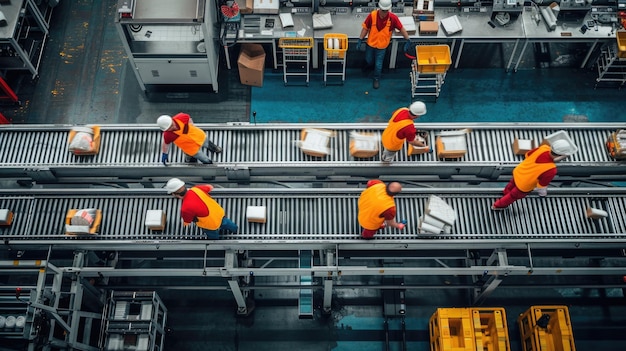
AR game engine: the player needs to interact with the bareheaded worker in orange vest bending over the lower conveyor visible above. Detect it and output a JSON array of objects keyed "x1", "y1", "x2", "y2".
[{"x1": 359, "y1": 180, "x2": 405, "y2": 239}]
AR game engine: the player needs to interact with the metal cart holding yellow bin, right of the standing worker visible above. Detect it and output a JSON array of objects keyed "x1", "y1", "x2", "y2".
[{"x1": 411, "y1": 45, "x2": 452, "y2": 101}]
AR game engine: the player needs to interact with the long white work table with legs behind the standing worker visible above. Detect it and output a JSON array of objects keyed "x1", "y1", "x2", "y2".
[{"x1": 225, "y1": 6, "x2": 615, "y2": 71}]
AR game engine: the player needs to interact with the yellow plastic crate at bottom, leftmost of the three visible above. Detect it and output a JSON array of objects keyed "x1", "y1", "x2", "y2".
[{"x1": 429, "y1": 308, "x2": 476, "y2": 351}]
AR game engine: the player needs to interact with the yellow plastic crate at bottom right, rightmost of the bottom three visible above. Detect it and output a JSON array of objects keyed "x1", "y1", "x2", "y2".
[{"x1": 517, "y1": 306, "x2": 576, "y2": 351}]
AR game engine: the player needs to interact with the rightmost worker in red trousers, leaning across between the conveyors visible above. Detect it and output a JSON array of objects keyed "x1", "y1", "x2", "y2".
[{"x1": 491, "y1": 139, "x2": 577, "y2": 210}]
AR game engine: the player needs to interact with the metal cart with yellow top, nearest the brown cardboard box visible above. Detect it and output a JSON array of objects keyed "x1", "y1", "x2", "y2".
[{"x1": 278, "y1": 38, "x2": 313, "y2": 86}]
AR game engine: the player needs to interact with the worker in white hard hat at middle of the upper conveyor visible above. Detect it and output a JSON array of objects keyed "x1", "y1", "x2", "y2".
[{"x1": 381, "y1": 101, "x2": 426, "y2": 162}]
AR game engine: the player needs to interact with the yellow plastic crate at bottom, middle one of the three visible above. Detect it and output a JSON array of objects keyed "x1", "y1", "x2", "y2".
[{"x1": 471, "y1": 307, "x2": 511, "y2": 351}]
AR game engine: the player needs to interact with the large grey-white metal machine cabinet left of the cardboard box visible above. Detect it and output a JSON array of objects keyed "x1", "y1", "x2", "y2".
[{"x1": 115, "y1": 0, "x2": 219, "y2": 95}]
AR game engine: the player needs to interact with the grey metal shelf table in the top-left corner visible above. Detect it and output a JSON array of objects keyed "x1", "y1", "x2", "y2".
[{"x1": 0, "y1": 0, "x2": 53, "y2": 79}]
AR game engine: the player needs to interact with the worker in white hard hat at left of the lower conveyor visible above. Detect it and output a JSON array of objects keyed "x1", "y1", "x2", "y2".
[{"x1": 165, "y1": 178, "x2": 239, "y2": 239}]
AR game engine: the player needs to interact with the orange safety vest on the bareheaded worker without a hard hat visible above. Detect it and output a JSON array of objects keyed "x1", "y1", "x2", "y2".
[{"x1": 359, "y1": 183, "x2": 396, "y2": 230}]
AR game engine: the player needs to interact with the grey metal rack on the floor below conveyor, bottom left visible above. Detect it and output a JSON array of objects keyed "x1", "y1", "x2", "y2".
[{"x1": 103, "y1": 291, "x2": 167, "y2": 351}]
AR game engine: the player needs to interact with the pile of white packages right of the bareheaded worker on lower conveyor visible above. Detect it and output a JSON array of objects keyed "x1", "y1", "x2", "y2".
[{"x1": 418, "y1": 195, "x2": 457, "y2": 234}]
